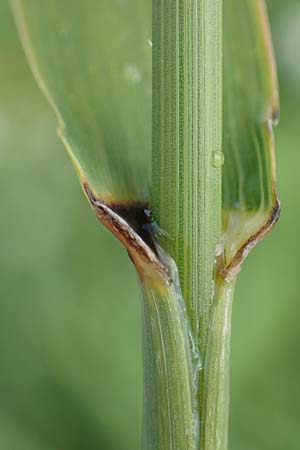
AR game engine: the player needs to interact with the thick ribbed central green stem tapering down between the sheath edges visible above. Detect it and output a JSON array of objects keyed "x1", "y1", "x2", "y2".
[{"x1": 152, "y1": 0, "x2": 225, "y2": 444}]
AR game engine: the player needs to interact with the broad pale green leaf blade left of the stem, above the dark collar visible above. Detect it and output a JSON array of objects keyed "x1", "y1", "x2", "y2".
[{"x1": 12, "y1": 0, "x2": 151, "y2": 201}]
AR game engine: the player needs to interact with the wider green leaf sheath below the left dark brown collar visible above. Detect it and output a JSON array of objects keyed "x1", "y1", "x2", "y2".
[{"x1": 142, "y1": 255, "x2": 199, "y2": 450}]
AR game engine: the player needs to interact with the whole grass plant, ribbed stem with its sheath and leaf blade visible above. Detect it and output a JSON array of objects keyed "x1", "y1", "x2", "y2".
[{"x1": 12, "y1": 0, "x2": 279, "y2": 450}]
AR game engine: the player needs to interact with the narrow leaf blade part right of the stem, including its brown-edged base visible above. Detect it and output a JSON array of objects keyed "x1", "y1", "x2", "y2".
[{"x1": 223, "y1": 0, "x2": 279, "y2": 280}]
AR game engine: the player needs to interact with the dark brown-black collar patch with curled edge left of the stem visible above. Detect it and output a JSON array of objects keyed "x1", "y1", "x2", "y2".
[{"x1": 83, "y1": 181, "x2": 171, "y2": 284}]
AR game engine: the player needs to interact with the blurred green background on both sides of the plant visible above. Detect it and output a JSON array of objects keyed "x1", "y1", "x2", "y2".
[{"x1": 0, "y1": 0, "x2": 300, "y2": 450}]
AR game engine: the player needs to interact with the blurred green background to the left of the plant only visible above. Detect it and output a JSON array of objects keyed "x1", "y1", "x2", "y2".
[{"x1": 0, "y1": 2, "x2": 141, "y2": 450}]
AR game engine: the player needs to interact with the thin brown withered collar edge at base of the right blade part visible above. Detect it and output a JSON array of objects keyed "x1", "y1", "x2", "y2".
[{"x1": 220, "y1": 198, "x2": 281, "y2": 283}]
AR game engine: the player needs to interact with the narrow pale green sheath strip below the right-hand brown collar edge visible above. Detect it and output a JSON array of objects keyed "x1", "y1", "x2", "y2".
[{"x1": 201, "y1": 280, "x2": 234, "y2": 450}]
